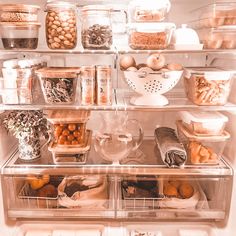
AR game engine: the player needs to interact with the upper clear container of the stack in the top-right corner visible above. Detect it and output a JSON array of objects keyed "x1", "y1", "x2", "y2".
[{"x1": 193, "y1": 2, "x2": 236, "y2": 28}]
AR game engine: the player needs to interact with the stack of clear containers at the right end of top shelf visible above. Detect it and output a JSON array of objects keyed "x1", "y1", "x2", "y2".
[{"x1": 191, "y1": 2, "x2": 236, "y2": 49}]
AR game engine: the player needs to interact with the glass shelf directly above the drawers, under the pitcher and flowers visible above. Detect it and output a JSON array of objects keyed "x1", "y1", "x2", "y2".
[{"x1": 2, "y1": 139, "x2": 233, "y2": 177}]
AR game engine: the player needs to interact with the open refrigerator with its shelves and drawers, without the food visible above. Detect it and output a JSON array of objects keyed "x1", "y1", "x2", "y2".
[{"x1": 0, "y1": 0, "x2": 236, "y2": 236}]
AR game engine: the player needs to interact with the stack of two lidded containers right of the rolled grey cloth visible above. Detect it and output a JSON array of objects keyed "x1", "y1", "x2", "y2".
[{"x1": 177, "y1": 111, "x2": 230, "y2": 165}]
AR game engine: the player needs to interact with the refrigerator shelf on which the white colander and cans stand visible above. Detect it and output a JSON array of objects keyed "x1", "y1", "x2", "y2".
[{"x1": 0, "y1": 89, "x2": 236, "y2": 111}]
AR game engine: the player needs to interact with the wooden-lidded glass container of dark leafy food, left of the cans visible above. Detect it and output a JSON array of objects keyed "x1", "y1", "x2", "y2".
[{"x1": 35, "y1": 67, "x2": 80, "y2": 104}]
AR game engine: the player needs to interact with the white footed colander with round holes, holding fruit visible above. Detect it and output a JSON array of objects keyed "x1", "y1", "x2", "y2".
[{"x1": 124, "y1": 70, "x2": 183, "y2": 106}]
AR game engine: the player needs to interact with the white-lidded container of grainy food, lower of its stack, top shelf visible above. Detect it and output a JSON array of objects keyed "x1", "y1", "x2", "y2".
[{"x1": 129, "y1": 23, "x2": 176, "y2": 50}]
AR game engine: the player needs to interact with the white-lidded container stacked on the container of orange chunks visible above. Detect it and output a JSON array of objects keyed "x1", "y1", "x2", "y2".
[{"x1": 180, "y1": 111, "x2": 228, "y2": 136}]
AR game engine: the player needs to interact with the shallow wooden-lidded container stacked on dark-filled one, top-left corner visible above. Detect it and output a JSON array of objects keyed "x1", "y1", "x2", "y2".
[{"x1": 0, "y1": 4, "x2": 40, "y2": 22}]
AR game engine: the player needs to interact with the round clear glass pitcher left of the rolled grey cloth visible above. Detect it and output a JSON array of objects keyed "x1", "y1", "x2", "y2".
[{"x1": 94, "y1": 111, "x2": 143, "y2": 164}]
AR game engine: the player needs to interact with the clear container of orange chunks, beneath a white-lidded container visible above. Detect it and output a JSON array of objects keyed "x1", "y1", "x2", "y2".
[{"x1": 177, "y1": 121, "x2": 230, "y2": 165}]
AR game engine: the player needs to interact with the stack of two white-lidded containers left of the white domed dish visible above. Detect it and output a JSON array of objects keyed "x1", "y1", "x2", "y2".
[{"x1": 129, "y1": 0, "x2": 176, "y2": 50}]
